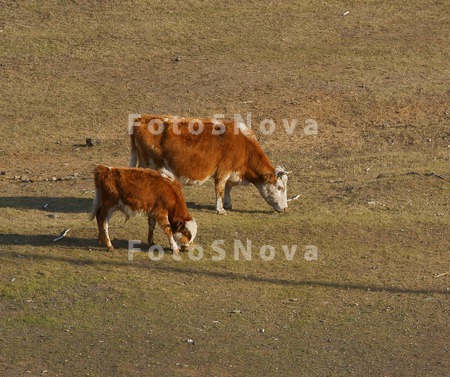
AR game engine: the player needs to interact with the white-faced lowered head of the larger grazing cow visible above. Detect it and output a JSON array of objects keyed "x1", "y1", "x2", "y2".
[{"x1": 256, "y1": 166, "x2": 290, "y2": 212}]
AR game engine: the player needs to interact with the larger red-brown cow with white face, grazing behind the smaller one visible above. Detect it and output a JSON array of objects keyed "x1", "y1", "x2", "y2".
[{"x1": 130, "y1": 115, "x2": 288, "y2": 214}]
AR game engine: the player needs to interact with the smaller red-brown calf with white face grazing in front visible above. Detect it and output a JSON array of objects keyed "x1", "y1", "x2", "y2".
[{"x1": 91, "y1": 165, "x2": 197, "y2": 254}]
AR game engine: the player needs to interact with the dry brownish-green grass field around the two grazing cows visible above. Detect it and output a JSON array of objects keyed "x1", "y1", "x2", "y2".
[{"x1": 0, "y1": 0, "x2": 450, "y2": 377}]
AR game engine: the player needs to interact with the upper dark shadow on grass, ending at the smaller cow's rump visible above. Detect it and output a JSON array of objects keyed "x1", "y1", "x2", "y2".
[{"x1": 0, "y1": 196, "x2": 93, "y2": 213}]
